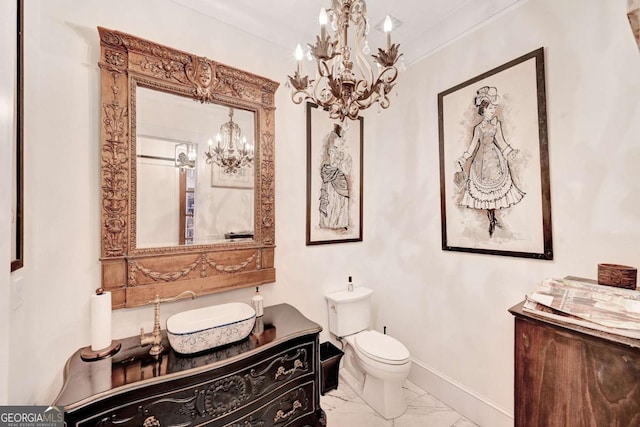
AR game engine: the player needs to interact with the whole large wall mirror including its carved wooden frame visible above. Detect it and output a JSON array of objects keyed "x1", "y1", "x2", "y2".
[{"x1": 98, "y1": 27, "x2": 278, "y2": 309}]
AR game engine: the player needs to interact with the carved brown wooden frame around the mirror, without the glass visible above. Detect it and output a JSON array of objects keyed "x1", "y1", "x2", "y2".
[{"x1": 98, "y1": 27, "x2": 278, "y2": 309}]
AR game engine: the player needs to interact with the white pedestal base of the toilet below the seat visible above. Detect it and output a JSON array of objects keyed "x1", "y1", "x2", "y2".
[{"x1": 340, "y1": 367, "x2": 407, "y2": 420}]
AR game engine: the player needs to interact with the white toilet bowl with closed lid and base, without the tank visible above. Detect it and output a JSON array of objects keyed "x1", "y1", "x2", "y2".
[{"x1": 341, "y1": 331, "x2": 411, "y2": 419}]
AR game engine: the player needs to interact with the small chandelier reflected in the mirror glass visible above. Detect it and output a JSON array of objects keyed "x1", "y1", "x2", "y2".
[{"x1": 204, "y1": 108, "x2": 254, "y2": 175}]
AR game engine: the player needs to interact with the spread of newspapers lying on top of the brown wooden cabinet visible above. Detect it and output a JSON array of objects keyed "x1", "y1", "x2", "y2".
[{"x1": 522, "y1": 279, "x2": 640, "y2": 338}]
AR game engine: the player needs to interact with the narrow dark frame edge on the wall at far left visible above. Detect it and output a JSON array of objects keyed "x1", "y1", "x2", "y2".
[{"x1": 11, "y1": 0, "x2": 24, "y2": 271}]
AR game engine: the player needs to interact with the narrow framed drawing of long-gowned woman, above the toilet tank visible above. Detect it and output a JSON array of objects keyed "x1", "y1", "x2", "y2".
[{"x1": 306, "y1": 103, "x2": 364, "y2": 245}]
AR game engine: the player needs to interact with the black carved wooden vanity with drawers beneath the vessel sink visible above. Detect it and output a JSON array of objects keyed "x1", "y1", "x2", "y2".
[{"x1": 55, "y1": 304, "x2": 326, "y2": 427}]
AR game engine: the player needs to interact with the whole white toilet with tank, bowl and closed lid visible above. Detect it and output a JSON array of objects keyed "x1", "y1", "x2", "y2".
[{"x1": 325, "y1": 286, "x2": 411, "y2": 419}]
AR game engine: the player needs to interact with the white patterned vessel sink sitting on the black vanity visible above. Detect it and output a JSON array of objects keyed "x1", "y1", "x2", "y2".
[{"x1": 167, "y1": 302, "x2": 256, "y2": 354}]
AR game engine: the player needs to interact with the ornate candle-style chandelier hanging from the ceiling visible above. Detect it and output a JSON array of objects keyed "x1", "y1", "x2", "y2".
[{"x1": 288, "y1": 0, "x2": 402, "y2": 121}]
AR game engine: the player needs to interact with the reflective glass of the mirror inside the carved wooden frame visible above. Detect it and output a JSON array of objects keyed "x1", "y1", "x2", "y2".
[{"x1": 136, "y1": 86, "x2": 255, "y2": 248}]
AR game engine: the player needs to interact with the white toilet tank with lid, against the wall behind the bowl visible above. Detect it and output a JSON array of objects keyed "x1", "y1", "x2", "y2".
[{"x1": 325, "y1": 286, "x2": 373, "y2": 337}]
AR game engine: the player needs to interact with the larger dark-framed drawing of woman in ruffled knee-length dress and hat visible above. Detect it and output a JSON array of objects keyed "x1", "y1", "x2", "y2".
[{"x1": 438, "y1": 48, "x2": 553, "y2": 260}]
